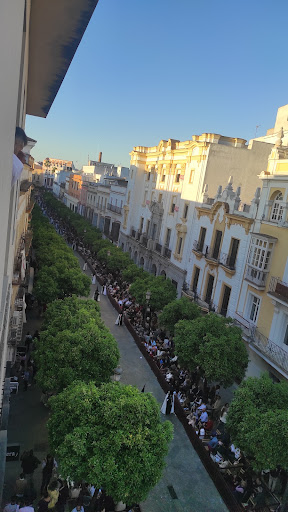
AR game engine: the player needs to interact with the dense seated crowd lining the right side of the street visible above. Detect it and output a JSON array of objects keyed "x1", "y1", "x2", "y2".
[{"x1": 5, "y1": 196, "x2": 287, "y2": 512}]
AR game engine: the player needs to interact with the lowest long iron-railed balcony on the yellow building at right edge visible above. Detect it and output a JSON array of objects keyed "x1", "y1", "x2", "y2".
[{"x1": 233, "y1": 313, "x2": 288, "y2": 374}]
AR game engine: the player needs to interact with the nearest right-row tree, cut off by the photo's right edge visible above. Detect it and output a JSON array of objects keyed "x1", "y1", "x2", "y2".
[{"x1": 227, "y1": 374, "x2": 288, "y2": 471}]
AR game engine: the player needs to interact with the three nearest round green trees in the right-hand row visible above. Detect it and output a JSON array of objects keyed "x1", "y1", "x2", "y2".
[{"x1": 159, "y1": 298, "x2": 288, "y2": 471}]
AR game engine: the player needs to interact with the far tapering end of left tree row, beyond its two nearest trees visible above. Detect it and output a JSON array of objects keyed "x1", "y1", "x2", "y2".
[{"x1": 32, "y1": 205, "x2": 90, "y2": 304}]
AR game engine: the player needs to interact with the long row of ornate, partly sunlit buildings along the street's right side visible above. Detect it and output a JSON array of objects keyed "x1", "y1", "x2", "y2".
[{"x1": 51, "y1": 105, "x2": 288, "y2": 380}]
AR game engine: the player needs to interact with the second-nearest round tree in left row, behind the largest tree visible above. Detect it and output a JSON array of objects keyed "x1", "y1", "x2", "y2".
[{"x1": 35, "y1": 322, "x2": 119, "y2": 393}]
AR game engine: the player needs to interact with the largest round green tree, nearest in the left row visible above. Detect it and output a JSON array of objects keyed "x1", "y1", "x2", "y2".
[{"x1": 48, "y1": 382, "x2": 173, "y2": 504}]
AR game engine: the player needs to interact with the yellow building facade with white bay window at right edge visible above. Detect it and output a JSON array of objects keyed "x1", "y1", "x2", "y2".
[{"x1": 236, "y1": 130, "x2": 288, "y2": 379}]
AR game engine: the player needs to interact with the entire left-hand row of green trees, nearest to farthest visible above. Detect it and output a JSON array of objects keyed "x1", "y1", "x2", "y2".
[{"x1": 33, "y1": 203, "x2": 173, "y2": 503}]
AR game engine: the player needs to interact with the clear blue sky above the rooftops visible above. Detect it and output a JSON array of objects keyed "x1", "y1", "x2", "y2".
[{"x1": 26, "y1": 0, "x2": 288, "y2": 169}]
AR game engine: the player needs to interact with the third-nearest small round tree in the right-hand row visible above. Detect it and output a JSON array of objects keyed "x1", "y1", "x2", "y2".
[{"x1": 158, "y1": 297, "x2": 200, "y2": 336}]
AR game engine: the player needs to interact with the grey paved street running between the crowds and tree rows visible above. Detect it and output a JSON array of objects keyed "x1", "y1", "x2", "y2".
[{"x1": 4, "y1": 257, "x2": 227, "y2": 512}]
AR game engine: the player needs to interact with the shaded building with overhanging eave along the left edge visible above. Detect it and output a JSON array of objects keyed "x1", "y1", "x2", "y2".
[{"x1": 0, "y1": 0, "x2": 98, "y2": 502}]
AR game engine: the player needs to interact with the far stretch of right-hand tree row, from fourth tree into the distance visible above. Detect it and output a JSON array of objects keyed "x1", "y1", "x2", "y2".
[{"x1": 44, "y1": 193, "x2": 177, "y2": 311}]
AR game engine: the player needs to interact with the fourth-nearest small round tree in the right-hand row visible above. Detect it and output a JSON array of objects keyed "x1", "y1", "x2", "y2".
[{"x1": 130, "y1": 273, "x2": 177, "y2": 311}]
